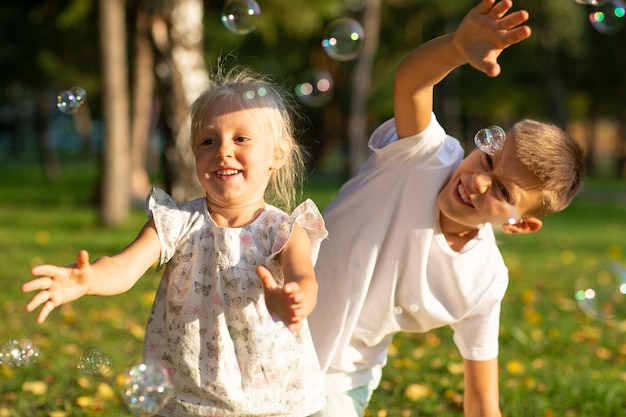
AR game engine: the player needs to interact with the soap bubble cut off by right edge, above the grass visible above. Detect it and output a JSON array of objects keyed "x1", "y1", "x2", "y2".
[{"x1": 574, "y1": 262, "x2": 626, "y2": 321}]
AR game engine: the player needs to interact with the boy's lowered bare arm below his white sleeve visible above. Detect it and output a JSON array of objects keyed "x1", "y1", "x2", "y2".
[{"x1": 463, "y1": 358, "x2": 502, "y2": 417}]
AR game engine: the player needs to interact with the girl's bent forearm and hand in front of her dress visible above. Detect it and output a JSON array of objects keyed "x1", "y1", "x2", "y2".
[{"x1": 257, "y1": 223, "x2": 318, "y2": 331}]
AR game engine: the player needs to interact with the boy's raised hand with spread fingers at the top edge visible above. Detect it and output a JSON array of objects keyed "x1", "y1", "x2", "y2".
[{"x1": 453, "y1": 0, "x2": 531, "y2": 77}]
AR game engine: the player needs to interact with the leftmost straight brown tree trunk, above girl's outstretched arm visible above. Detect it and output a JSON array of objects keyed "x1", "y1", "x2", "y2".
[{"x1": 99, "y1": 0, "x2": 130, "y2": 226}]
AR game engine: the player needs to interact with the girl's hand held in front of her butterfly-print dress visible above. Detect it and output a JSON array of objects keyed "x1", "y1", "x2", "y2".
[{"x1": 256, "y1": 266, "x2": 304, "y2": 332}]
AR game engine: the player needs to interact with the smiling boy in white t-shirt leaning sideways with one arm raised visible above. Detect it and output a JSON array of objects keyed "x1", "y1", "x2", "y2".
[{"x1": 309, "y1": 0, "x2": 584, "y2": 417}]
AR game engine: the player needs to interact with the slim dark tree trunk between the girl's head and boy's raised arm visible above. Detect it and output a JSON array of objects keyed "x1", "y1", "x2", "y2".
[{"x1": 348, "y1": 0, "x2": 381, "y2": 176}]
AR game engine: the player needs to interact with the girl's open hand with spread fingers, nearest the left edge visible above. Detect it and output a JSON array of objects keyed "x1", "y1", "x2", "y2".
[{"x1": 22, "y1": 250, "x2": 91, "y2": 323}]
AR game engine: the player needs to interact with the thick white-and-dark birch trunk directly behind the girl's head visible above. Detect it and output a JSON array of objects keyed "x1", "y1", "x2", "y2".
[{"x1": 152, "y1": 0, "x2": 208, "y2": 201}]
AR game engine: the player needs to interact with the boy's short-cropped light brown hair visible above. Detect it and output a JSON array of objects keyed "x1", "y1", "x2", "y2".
[{"x1": 508, "y1": 119, "x2": 585, "y2": 217}]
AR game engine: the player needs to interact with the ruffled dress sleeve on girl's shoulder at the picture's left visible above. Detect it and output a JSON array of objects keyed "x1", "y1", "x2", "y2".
[{"x1": 145, "y1": 187, "x2": 199, "y2": 269}]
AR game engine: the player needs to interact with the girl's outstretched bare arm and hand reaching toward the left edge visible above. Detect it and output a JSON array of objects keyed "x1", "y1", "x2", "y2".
[{"x1": 22, "y1": 219, "x2": 161, "y2": 323}]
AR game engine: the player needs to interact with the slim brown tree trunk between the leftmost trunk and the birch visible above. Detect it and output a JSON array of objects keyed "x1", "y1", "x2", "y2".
[{"x1": 130, "y1": 5, "x2": 154, "y2": 203}]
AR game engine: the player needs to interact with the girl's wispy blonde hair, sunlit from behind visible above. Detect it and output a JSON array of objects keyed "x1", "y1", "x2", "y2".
[{"x1": 191, "y1": 67, "x2": 305, "y2": 211}]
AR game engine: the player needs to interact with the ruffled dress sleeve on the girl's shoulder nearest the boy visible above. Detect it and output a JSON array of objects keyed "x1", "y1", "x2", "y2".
[{"x1": 269, "y1": 199, "x2": 328, "y2": 265}]
